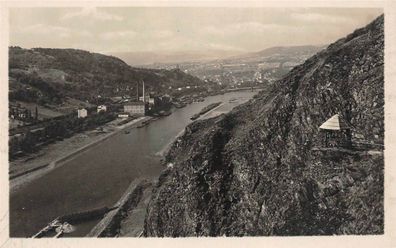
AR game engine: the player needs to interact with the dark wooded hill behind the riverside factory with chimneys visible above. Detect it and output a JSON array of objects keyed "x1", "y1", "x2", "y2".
[{"x1": 9, "y1": 47, "x2": 202, "y2": 114}]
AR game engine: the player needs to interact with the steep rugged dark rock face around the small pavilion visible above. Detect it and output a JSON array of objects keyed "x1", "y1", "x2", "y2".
[{"x1": 144, "y1": 16, "x2": 384, "y2": 236}]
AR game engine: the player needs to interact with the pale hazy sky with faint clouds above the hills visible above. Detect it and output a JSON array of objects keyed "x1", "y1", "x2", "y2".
[{"x1": 10, "y1": 7, "x2": 382, "y2": 52}]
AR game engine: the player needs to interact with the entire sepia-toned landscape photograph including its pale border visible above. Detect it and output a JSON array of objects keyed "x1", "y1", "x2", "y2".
[{"x1": 2, "y1": 2, "x2": 392, "y2": 247}]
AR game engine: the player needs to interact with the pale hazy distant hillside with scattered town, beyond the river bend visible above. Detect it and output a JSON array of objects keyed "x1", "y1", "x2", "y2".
[{"x1": 145, "y1": 45, "x2": 325, "y2": 84}]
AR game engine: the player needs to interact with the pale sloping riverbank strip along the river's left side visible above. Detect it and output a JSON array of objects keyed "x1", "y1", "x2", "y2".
[{"x1": 9, "y1": 116, "x2": 152, "y2": 192}]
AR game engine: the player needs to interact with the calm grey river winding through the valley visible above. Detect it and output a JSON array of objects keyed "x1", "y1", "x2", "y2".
[{"x1": 10, "y1": 91, "x2": 257, "y2": 237}]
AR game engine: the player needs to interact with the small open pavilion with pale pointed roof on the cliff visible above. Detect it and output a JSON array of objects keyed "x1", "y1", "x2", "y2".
[{"x1": 319, "y1": 114, "x2": 352, "y2": 147}]
